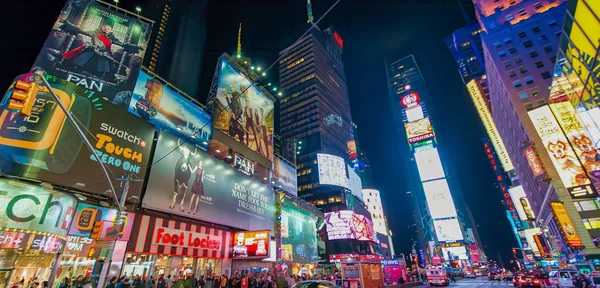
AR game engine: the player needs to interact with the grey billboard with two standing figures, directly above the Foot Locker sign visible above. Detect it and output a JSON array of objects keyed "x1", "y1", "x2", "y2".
[{"x1": 142, "y1": 131, "x2": 275, "y2": 231}]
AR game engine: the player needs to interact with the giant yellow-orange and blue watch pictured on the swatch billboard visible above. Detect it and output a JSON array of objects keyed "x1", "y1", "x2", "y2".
[{"x1": 0, "y1": 76, "x2": 91, "y2": 174}]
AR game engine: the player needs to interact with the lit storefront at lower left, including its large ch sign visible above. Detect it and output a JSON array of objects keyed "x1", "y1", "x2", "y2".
[{"x1": 0, "y1": 178, "x2": 77, "y2": 287}]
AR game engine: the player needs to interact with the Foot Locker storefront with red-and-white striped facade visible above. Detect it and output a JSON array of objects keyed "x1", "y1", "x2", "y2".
[{"x1": 122, "y1": 214, "x2": 233, "y2": 277}]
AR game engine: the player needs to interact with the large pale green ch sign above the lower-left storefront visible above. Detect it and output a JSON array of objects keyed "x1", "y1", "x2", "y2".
[{"x1": 0, "y1": 178, "x2": 77, "y2": 236}]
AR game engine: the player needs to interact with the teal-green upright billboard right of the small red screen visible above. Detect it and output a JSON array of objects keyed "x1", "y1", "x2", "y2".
[{"x1": 281, "y1": 197, "x2": 319, "y2": 264}]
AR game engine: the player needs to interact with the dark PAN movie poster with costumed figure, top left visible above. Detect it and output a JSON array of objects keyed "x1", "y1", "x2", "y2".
[{"x1": 33, "y1": 0, "x2": 152, "y2": 107}]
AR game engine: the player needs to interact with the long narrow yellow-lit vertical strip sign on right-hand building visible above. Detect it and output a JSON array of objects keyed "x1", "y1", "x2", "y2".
[{"x1": 467, "y1": 79, "x2": 514, "y2": 172}]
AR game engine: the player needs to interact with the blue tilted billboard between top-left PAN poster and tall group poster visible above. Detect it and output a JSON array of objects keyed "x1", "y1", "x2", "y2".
[{"x1": 129, "y1": 71, "x2": 212, "y2": 151}]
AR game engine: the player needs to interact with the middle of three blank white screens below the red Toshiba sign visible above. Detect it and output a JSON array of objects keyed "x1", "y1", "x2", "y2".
[{"x1": 423, "y1": 179, "x2": 456, "y2": 219}]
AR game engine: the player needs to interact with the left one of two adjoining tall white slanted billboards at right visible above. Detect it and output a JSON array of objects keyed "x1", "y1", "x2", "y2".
[{"x1": 528, "y1": 106, "x2": 596, "y2": 199}]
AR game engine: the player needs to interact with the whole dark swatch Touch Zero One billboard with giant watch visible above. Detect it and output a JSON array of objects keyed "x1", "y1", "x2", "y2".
[{"x1": 0, "y1": 74, "x2": 154, "y2": 202}]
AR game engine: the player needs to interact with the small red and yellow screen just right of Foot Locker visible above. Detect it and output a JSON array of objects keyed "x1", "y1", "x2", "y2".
[{"x1": 232, "y1": 231, "x2": 270, "y2": 259}]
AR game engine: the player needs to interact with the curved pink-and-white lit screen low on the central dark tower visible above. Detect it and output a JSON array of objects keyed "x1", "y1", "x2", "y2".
[{"x1": 325, "y1": 210, "x2": 375, "y2": 241}]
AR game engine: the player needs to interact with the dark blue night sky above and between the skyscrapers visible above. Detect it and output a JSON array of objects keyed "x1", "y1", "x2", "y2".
[{"x1": 0, "y1": 0, "x2": 517, "y2": 264}]
